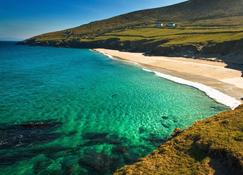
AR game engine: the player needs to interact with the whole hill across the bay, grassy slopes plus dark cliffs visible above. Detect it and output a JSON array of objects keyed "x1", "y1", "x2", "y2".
[{"x1": 22, "y1": 0, "x2": 243, "y2": 67}]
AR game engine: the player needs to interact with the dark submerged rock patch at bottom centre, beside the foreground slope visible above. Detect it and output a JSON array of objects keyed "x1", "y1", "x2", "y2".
[{"x1": 79, "y1": 132, "x2": 164, "y2": 174}]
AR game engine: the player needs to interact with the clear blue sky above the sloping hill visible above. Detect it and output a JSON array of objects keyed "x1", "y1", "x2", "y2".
[{"x1": 0, "y1": 0, "x2": 184, "y2": 41}]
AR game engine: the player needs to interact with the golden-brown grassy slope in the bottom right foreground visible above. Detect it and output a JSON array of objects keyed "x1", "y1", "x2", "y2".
[{"x1": 115, "y1": 106, "x2": 243, "y2": 175}]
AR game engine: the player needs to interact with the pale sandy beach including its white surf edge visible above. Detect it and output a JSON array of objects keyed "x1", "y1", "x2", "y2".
[{"x1": 94, "y1": 49, "x2": 243, "y2": 109}]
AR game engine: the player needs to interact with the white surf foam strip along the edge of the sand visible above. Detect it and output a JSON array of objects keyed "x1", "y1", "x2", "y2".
[{"x1": 143, "y1": 68, "x2": 241, "y2": 109}]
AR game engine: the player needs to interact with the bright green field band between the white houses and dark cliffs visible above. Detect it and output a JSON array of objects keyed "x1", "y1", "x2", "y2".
[{"x1": 94, "y1": 27, "x2": 243, "y2": 46}]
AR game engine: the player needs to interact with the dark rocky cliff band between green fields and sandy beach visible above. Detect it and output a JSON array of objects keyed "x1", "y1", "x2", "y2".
[{"x1": 18, "y1": 38, "x2": 243, "y2": 75}]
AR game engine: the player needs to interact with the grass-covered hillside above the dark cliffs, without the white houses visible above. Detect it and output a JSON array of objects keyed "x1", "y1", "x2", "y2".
[{"x1": 24, "y1": 0, "x2": 243, "y2": 49}]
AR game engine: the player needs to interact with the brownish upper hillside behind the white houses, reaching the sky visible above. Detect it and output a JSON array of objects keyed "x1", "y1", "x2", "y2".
[{"x1": 24, "y1": 0, "x2": 243, "y2": 40}]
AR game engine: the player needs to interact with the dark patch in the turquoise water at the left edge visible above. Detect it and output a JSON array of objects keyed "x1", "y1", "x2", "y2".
[{"x1": 0, "y1": 120, "x2": 61, "y2": 165}]
